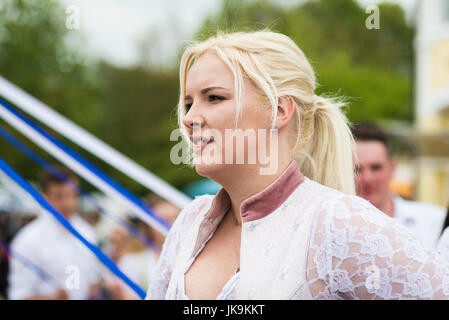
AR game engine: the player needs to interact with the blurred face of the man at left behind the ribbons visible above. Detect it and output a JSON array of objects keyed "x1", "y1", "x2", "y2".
[{"x1": 44, "y1": 183, "x2": 78, "y2": 218}]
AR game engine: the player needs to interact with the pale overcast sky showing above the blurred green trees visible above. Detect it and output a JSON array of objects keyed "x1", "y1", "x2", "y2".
[{"x1": 61, "y1": 0, "x2": 416, "y2": 65}]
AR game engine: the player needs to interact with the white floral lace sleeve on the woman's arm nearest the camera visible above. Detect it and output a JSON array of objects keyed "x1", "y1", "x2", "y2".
[{"x1": 307, "y1": 196, "x2": 449, "y2": 299}]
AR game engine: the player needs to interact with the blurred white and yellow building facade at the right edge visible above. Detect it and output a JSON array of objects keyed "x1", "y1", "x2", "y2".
[{"x1": 415, "y1": 0, "x2": 449, "y2": 207}]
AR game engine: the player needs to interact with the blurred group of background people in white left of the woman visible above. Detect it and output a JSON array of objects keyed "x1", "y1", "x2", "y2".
[{"x1": 0, "y1": 166, "x2": 180, "y2": 300}]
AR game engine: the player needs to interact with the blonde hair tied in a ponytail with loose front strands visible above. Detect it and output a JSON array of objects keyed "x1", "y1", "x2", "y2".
[{"x1": 178, "y1": 30, "x2": 354, "y2": 194}]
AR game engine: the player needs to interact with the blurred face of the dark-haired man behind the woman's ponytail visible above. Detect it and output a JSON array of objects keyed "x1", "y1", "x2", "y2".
[{"x1": 355, "y1": 140, "x2": 396, "y2": 208}]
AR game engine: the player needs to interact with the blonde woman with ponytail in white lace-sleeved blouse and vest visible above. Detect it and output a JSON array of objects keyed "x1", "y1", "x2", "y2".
[{"x1": 147, "y1": 31, "x2": 449, "y2": 299}]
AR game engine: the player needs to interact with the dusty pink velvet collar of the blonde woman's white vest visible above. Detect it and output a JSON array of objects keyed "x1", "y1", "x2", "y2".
[{"x1": 205, "y1": 160, "x2": 304, "y2": 223}]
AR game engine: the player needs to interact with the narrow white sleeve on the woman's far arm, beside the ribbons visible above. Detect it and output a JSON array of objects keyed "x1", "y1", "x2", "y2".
[{"x1": 145, "y1": 195, "x2": 210, "y2": 300}]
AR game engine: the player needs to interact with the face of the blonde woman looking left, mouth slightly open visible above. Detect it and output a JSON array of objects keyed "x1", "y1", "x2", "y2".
[{"x1": 183, "y1": 51, "x2": 271, "y2": 178}]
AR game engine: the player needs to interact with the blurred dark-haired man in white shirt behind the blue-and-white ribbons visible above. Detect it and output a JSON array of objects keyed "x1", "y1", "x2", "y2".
[{"x1": 8, "y1": 167, "x2": 101, "y2": 300}]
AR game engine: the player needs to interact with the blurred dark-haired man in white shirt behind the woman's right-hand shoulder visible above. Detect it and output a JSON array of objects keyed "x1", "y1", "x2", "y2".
[{"x1": 352, "y1": 123, "x2": 445, "y2": 250}]
